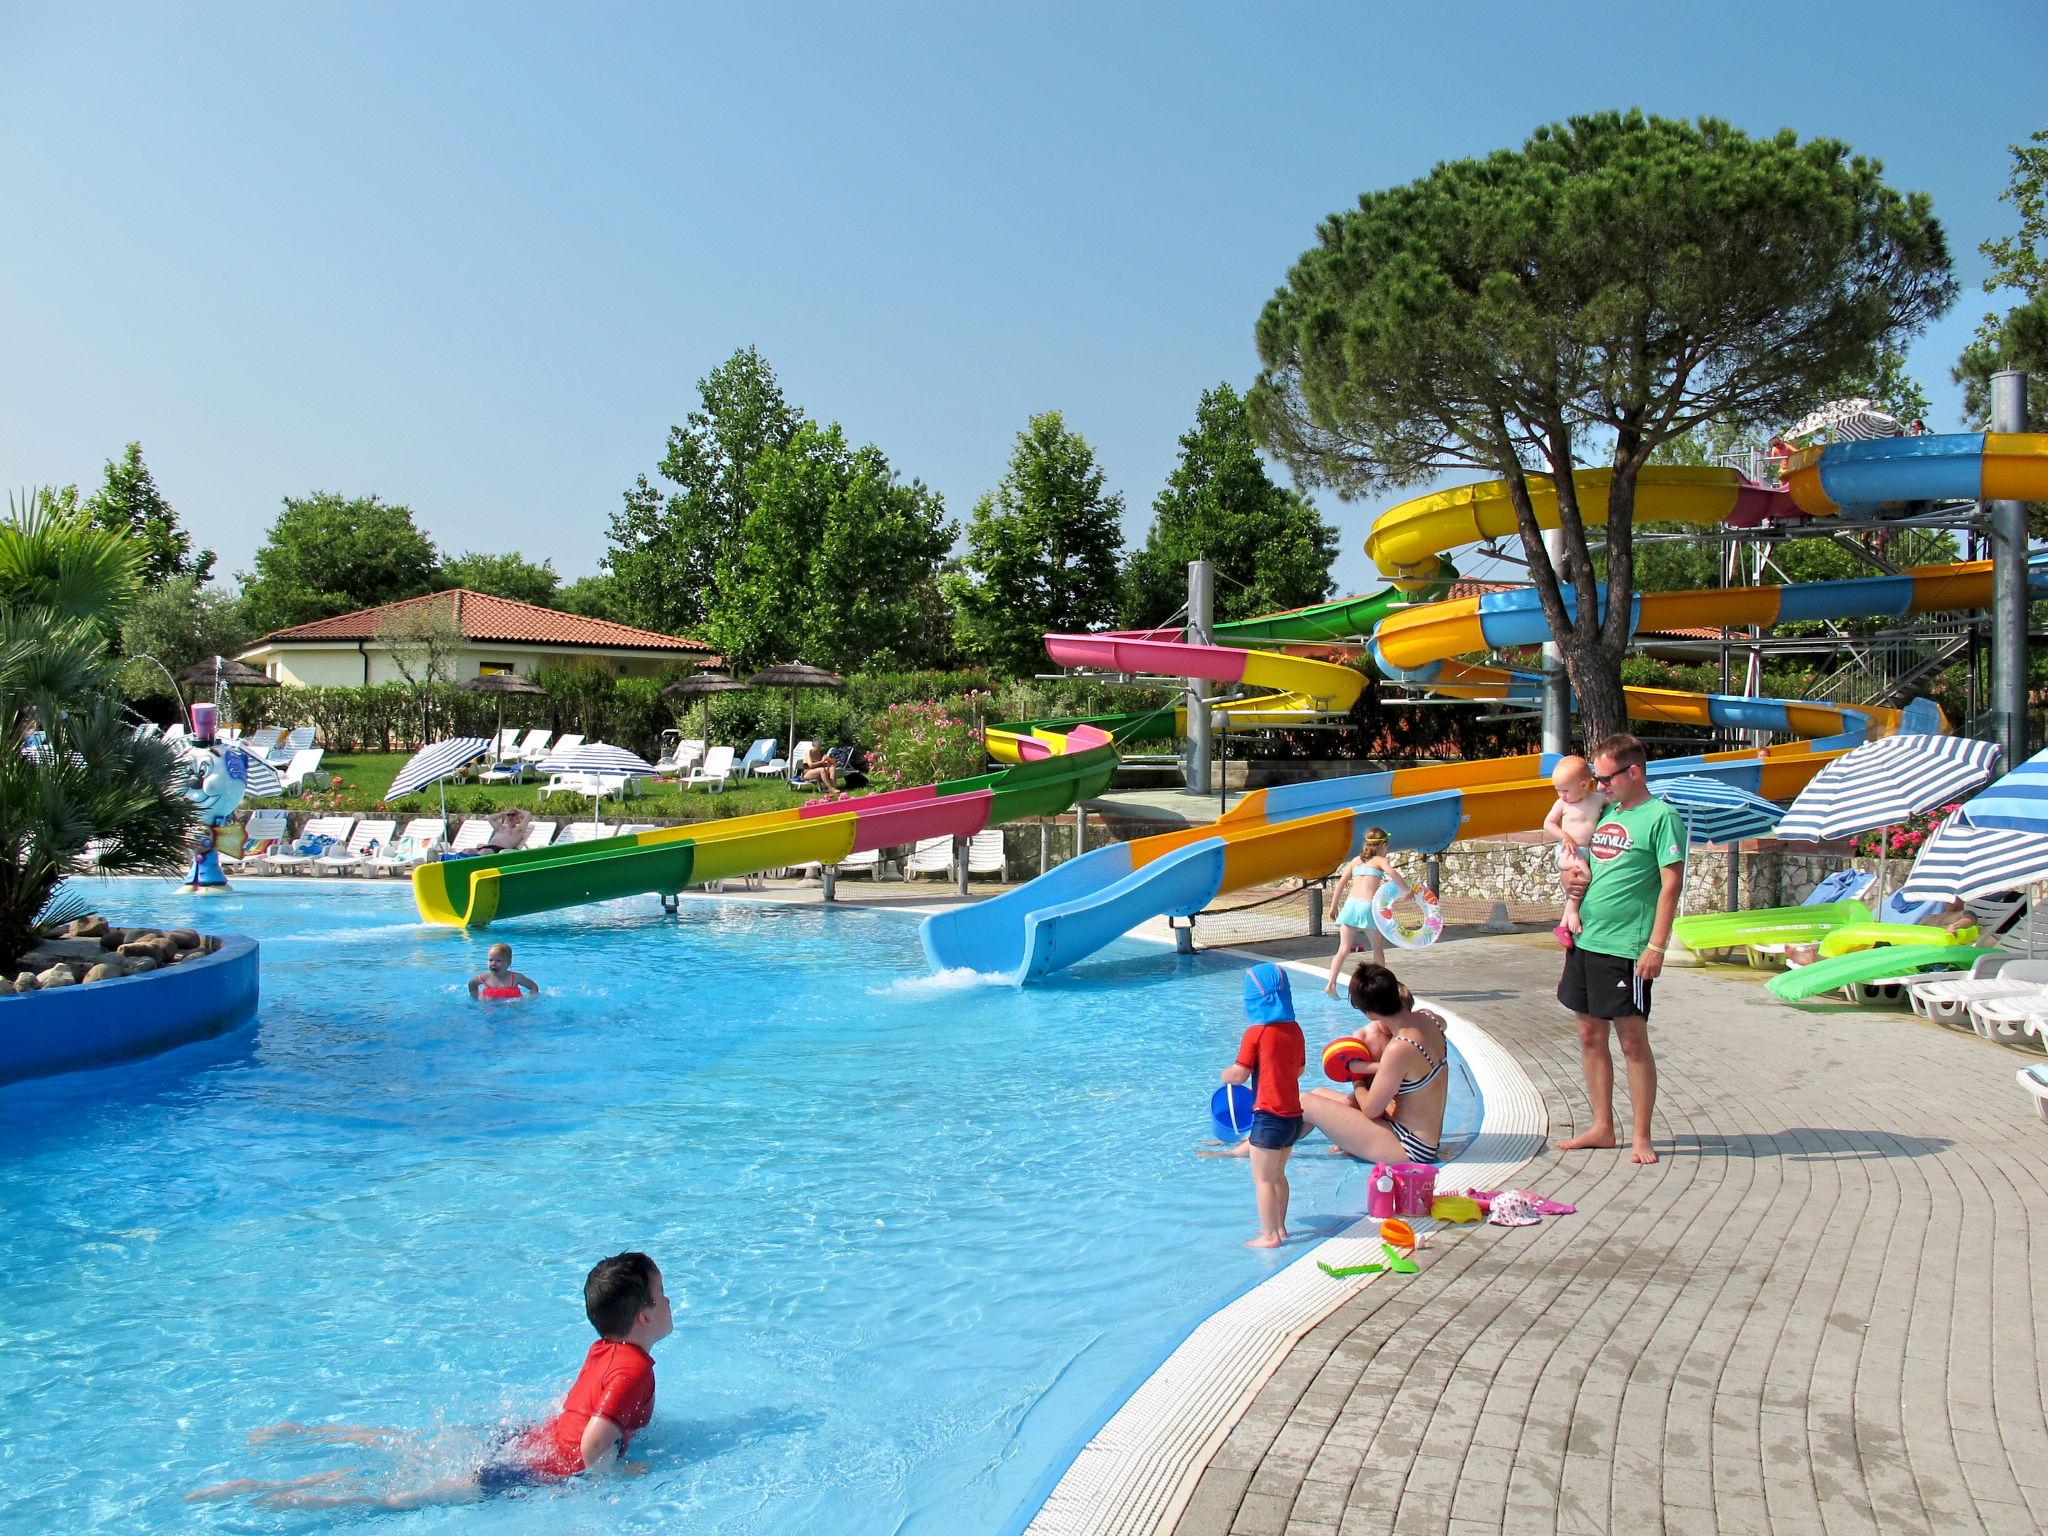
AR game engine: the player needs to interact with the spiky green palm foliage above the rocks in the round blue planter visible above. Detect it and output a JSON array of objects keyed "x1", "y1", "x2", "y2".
[{"x1": 0, "y1": 492, "x2": 193, "y2": 973}]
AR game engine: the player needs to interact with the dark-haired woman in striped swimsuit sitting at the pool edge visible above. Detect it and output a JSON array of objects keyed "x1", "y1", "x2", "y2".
[{"x1": 1300, "y1": 965, "x2": 1450, "y2": 1163}]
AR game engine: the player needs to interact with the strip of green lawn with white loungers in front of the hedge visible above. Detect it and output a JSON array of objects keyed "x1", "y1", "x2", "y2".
[{"x1": 242, "y1": 752, "x2": 807, "y2": 821}]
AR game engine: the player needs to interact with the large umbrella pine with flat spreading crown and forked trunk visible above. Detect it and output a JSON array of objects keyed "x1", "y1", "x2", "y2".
[{"x1": 1253, "y1": 113, "x2": 1956, "y2": 735}]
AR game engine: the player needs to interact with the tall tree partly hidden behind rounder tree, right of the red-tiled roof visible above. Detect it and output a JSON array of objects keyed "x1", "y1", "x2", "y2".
[{"x1": 604, "y1": 346, "x2": 799, "y2": 635}]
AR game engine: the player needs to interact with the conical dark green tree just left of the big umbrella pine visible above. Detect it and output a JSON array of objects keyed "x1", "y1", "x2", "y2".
[{"x1": 1124, "y1": 383, "x2": 1337, "y2": 627}]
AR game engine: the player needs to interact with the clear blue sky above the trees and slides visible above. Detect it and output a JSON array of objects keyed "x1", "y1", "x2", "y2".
[{"x1": 0, "y1": 0, "x2": 2048, "y2": 606}]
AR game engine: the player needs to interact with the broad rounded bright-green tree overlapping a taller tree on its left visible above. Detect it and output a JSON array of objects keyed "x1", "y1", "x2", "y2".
[{"x1": 707, "y1": 422, "x2": 956, "y2": 672}]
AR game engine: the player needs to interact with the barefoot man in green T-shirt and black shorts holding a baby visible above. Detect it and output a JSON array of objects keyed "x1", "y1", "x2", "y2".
[{"x1": 1556, "y1": 735, "x2": 1686, "y2": 1163}]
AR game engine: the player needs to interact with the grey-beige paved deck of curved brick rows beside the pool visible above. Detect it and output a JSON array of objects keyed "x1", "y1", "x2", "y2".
[{"x1": 1176, "y1": 936, "x2": 2048, "y2": 1536}]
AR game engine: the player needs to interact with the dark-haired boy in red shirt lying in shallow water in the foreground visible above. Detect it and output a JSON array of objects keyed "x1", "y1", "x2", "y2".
[{"x1": 184, "y1": 1251, "x2": 676, "y2": 1509}]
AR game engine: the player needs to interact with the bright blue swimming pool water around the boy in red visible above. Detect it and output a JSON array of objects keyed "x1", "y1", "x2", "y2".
[{"x1": 0, "y1": 883, "x2": 1477, "y2": 1534}]
